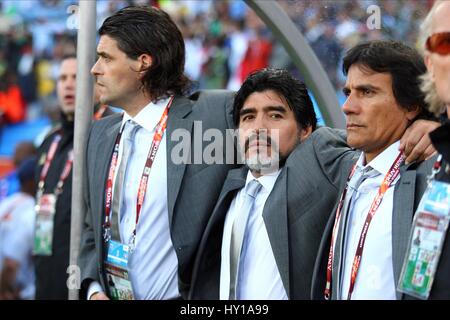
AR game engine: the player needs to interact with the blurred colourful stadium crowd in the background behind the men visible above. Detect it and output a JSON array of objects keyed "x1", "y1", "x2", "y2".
[{"x1": 0, "y1": 0, "x2": 431, "y2": 124}]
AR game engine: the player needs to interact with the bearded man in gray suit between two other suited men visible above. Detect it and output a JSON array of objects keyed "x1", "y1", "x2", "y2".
[{"x1": 190, "y1": 69, "x2": 355, "y2": 299}]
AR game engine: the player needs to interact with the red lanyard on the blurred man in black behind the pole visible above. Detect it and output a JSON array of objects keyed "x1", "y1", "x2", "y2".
[{"x1": 37, "y1": 134, "x2": 73, "y2": 199}]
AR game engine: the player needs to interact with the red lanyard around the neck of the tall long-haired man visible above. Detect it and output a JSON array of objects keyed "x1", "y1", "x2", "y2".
[{"x1": 104, "y1": 97, "x2": 173, "y2": 241}]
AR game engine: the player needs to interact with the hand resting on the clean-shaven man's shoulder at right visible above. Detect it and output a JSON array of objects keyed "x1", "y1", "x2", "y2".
[{"x1": 399, "y1": 120, "x2": 441, "y2": 164}]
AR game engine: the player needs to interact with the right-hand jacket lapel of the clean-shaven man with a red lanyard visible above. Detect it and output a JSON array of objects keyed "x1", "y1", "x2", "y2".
[{"x1": 392, "y1": 168, "x2": 416, "y2": 299}]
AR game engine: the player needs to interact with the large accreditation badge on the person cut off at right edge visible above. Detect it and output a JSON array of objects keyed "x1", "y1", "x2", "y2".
[{"x1": 398, "y1": 180, "x2": 450, "y2": 299}]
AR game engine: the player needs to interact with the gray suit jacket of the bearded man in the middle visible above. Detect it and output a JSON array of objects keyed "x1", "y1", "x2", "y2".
[{"x1": 189, "y1": 128, "x2": 356, "y2": 299}]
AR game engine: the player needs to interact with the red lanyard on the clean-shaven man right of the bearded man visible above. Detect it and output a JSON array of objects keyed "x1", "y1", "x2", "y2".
[{"x1": 324, "y1": 153, "x2": 405, "y2": 300}]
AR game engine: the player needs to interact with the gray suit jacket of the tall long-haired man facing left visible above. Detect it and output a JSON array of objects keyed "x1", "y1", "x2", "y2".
[{"x1": 79, "y1": 90, "x2": 235, "y2": 298}]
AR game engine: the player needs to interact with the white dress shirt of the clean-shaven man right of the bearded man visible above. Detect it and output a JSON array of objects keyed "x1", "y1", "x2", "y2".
[{"x1": 340, "y1": 141, "x2": 400, "y2": 300}]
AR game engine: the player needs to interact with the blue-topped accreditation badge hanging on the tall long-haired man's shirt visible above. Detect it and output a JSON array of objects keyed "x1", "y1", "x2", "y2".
[{"x1": 105, "y1": 240, "x2": 134, "y2": 300}]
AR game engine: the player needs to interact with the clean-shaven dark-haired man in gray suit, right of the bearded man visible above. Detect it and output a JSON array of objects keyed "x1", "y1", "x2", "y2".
[{"x1": 312, "y1": 41, "x2": 432, "y2": 299}]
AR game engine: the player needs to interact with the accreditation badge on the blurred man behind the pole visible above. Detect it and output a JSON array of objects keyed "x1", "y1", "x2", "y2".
[{"x1": 33, "y1": 194, "x2": 57, "y2": 256}]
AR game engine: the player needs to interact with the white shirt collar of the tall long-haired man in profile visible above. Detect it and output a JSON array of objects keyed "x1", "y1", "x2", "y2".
[{"x1": 120, "y1": 97, "x2": 171, "y2": 132}]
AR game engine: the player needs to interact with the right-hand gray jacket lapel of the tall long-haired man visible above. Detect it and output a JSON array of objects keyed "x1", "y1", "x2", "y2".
[{"x1": 166, "y1": 97, "x2": 194, "y2": 225}]
